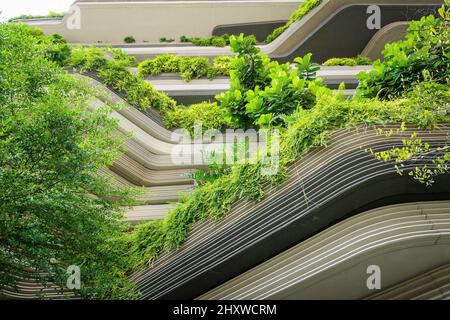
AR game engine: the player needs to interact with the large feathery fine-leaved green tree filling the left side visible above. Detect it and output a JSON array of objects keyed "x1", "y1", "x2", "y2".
[{"x1": 0, "y1": 24, "x2": 140, "y2": 299}]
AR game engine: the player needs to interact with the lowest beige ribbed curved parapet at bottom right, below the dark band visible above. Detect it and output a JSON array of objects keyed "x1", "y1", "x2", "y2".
[{"x1": 199, "y1": 201, "x2": 450, "y2": 300}]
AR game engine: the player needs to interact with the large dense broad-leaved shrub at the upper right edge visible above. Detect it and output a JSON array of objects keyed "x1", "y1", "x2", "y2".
[{"x1": 357, "y1": 0, "x2": 450, "y2": 99}]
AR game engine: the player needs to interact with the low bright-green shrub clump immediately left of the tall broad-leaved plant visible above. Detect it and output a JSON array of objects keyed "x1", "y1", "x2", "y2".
[{"x1": 165, "y1": 102, "x2": 227, "y2": 136}]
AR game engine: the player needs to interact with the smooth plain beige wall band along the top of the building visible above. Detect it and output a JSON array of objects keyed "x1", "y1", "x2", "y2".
[{"x1": 24, "y1": 0, "x2": 299, "y2": 44}]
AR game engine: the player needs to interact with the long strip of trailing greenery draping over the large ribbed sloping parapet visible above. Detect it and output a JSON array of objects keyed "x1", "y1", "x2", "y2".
[{"x1": 130, "y1": 82, "x2": 450, "y2": 266}]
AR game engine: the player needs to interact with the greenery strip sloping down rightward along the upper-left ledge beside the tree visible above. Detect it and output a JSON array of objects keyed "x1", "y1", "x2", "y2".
[{"x1": 68, "y1": 46, "x2": 176, "y2": 117}]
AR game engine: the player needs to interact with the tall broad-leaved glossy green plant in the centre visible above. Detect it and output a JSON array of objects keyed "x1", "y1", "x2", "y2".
[{"x1": 216, "y1": 34, "x2": 320, "y2": 128}]
